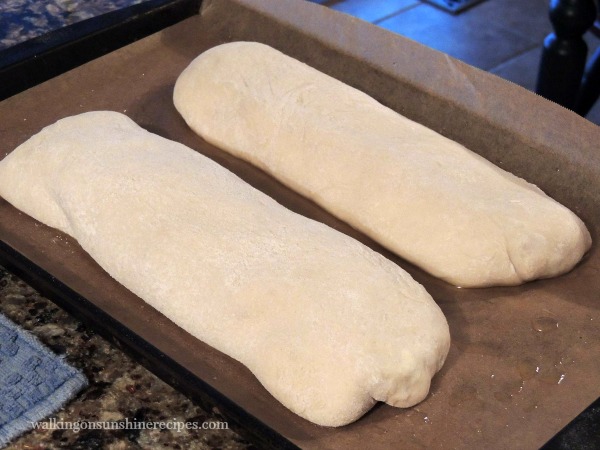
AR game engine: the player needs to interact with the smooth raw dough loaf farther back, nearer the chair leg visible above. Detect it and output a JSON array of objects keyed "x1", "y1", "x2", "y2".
[{"x1": 174, "y1": 42, "x2": 591, "y2": 287}]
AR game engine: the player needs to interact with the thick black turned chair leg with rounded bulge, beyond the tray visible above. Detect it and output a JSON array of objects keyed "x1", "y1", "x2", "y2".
[{"x1": 536, "y1": 0, "x2": 596, "y2": 109}]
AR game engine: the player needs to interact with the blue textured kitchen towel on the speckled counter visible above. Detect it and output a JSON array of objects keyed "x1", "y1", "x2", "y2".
[{"x1": 0, "y1": 314, "x2": 87, "y2": 448}]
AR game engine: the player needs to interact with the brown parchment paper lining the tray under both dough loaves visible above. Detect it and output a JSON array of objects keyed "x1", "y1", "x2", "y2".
[{"x1": 0, "y1": 0, "x2": 600, "y2": 449}]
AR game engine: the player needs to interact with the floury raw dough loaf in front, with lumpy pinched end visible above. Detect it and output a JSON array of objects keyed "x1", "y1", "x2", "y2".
[{"x1": 0, "y1": 112, "x2": 450, "y2": 426}]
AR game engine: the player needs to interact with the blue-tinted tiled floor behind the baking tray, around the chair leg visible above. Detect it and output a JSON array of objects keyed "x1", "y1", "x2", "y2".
[{"x1": 316, "y1": 0, "x2": 600, "y2": 124}]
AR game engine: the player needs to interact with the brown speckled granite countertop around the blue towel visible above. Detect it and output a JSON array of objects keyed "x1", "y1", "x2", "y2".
[{"x1": 0, "y1": 267, "x2": 253, "y2": 450}]
